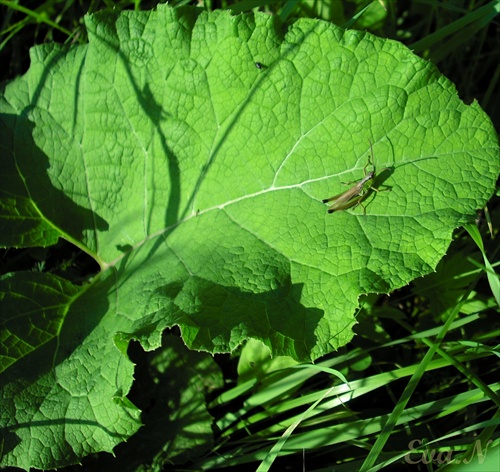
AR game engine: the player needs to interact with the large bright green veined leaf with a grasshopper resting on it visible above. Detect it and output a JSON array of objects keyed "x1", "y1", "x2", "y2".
[{"x1": 0, "y1": 5, "x2": 500, "y2": 468}]
